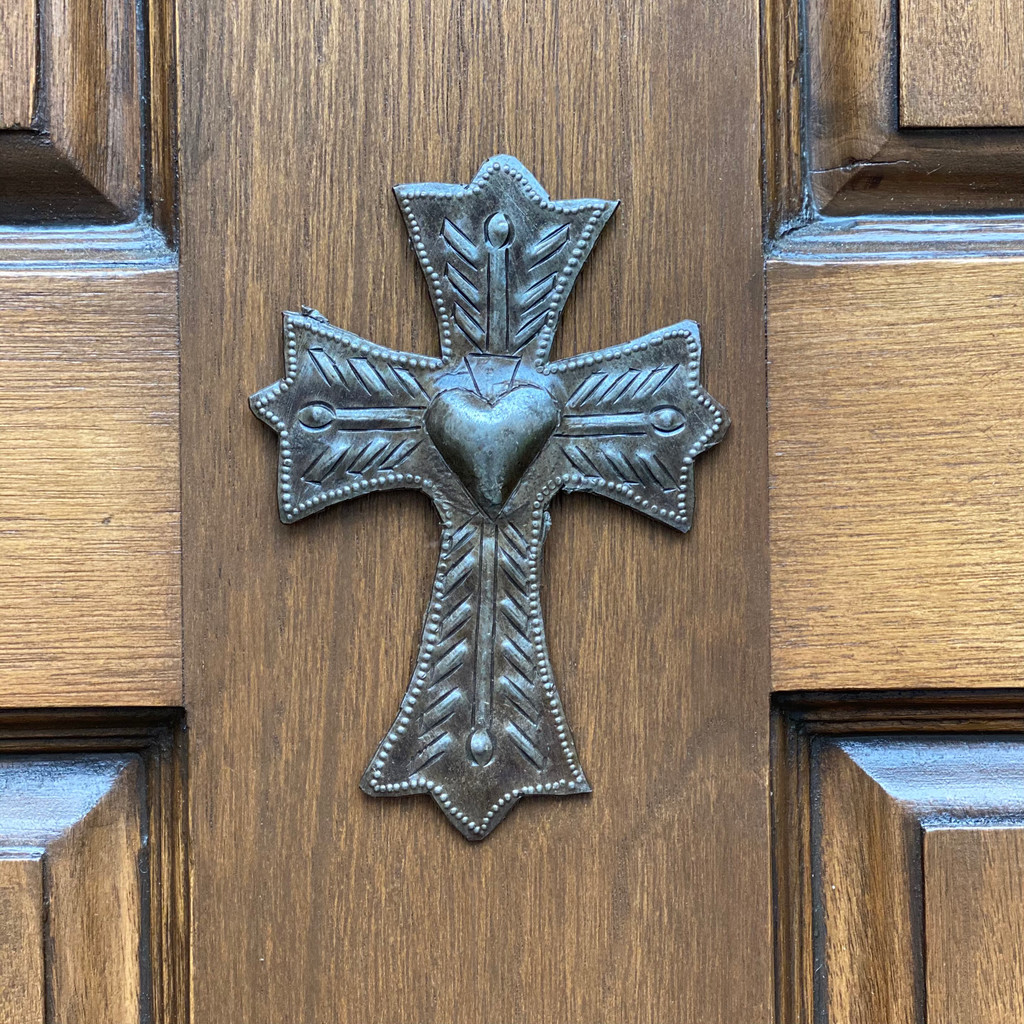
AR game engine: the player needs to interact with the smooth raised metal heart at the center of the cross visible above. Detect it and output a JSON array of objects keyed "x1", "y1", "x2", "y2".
[{"x1": 424, "y1": 386, "x2": 559, "y2": 517}]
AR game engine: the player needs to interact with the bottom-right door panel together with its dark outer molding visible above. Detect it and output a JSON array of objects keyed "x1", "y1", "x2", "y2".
[{"x1": 774, "y1": 708, "x2": 1024, "y2": 1024}]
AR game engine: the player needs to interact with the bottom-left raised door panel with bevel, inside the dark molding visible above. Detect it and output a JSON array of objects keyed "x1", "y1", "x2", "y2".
[{"x1": 0, "y1": 756, "x2": 150, "y2": 1024}]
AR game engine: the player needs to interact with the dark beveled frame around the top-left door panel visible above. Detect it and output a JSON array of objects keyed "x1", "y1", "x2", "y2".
[{"x1": 0, "y1": 0, "x2": 178, "y2": 238}]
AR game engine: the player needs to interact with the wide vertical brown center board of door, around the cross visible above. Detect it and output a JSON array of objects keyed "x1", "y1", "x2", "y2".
[{"x1": 180, "y1": 0, "x2": 771, "y2": 1024}]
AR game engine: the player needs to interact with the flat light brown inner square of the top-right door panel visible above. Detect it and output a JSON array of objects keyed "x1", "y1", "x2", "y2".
[{"x1": 899, "y1": 0, "x2": 1024, "y2": 128}]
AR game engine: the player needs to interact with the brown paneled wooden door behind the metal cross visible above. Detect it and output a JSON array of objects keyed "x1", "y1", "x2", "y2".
[{"x1": 0, "y1": 0, "x2": 1024, "y2": 1024}]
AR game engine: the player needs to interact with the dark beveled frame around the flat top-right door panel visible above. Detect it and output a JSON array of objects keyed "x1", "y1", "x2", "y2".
[{"x1": 786, "y1": 0, "x2": 1024, "y2": 214}]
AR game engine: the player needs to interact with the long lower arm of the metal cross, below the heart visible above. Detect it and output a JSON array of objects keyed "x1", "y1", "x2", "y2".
[{"x1": 361, "y1": 510, "x2": 590, "y2": 838}]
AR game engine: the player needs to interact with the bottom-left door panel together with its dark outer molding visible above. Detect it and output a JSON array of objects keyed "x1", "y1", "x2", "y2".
[{"x1": 0, "y1": 708, "x2": 188, "y2": 1024}]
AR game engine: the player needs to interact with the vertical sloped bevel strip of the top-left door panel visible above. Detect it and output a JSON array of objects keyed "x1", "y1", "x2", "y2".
[{"x1": 39, "y1": 0, "x2": 142, "y2": 219}]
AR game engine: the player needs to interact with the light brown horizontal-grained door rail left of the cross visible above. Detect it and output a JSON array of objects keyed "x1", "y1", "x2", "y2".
[{"x1": 0, "y1": 268, "x2": 181, "y2": 707}]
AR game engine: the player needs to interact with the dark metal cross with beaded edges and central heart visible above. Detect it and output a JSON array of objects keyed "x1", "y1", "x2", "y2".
[{"x1": 250, "y1": 157, "x2": 728, "y2": 840}]
